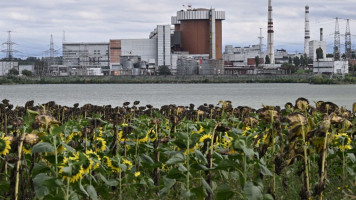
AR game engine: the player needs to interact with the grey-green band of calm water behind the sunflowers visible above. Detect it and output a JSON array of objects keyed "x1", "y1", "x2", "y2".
[{"x1": 0, "y1": 83, "x2": 356, "y2": 109}]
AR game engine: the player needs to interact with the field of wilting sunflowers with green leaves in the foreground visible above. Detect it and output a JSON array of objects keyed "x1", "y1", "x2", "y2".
[{"x1": 0, "y1": 98, "x2": 356, "y2": 200}]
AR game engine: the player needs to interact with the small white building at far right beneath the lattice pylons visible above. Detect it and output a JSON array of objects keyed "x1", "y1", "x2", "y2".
[{"x1": 313, "y1": 60, "x2": 349, "y2": 74}]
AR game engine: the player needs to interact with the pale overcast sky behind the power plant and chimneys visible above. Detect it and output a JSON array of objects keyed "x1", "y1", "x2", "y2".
[{"x1": 0, "y1": 0, "x2": 356, "y2": 57}]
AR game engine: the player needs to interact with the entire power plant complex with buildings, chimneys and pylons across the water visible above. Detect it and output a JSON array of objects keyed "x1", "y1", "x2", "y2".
[{"x1": 0, "y1": 0, "x2": 354, "y2": 76}]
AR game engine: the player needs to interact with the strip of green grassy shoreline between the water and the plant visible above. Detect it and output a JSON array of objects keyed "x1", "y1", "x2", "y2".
[{"x1": 0, "y1": 74, "x2": 356, "y2": 85}]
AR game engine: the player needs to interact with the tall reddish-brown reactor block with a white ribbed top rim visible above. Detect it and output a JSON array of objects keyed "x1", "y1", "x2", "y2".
[{"x1": 171, "y1": 8, "x2": 225, "y2": 59}]
